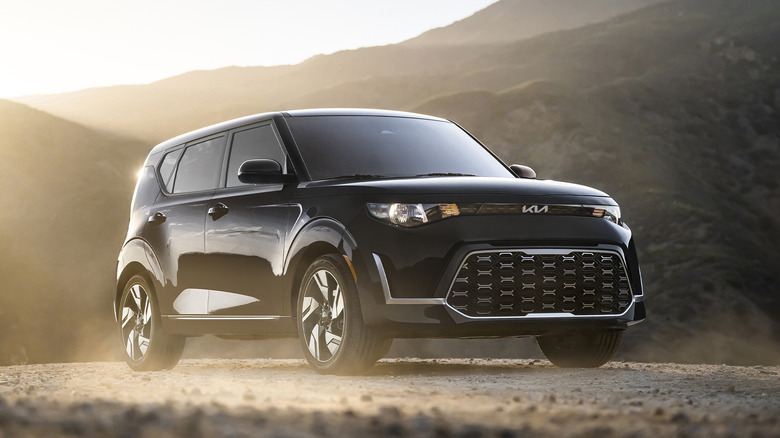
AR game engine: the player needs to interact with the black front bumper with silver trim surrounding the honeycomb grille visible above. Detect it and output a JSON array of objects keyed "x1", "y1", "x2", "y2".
[{"x1": 348, "y1": 217, "x2": 646, "y2": 337}]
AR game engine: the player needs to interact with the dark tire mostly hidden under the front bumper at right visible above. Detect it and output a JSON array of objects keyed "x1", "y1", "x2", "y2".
[{"x1": 536, "y1": 330, "x2": 623, "y2": 368}]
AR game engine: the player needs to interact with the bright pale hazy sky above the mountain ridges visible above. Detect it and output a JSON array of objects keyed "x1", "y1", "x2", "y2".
[{"x1": 0, "y1": 0, "x2": 496, "y2": 98}]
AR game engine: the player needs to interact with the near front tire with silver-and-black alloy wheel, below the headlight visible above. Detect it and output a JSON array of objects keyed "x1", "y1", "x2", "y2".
[{"x1": 296, "y1": 254, "x2": 389, "y2": 375}]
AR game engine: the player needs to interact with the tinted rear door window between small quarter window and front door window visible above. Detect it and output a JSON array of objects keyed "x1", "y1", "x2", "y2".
[{"x1": 173, "y1": 137, "x2": 225, "y2": 193}]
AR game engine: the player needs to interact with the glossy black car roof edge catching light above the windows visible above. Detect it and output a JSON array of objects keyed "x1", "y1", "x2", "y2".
[{"x1": 149, "y1": 108, "x2": 445, "y2": 156}]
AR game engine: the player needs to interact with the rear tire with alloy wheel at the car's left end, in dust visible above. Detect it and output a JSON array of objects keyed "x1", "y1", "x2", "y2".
[{"x1": 119, "y1": 275, "x2": 185, "y2": 371}]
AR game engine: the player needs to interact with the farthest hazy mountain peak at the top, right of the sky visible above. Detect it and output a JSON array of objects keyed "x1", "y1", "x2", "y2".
[{"x1": 403, "y1": 0, "x2": 665, "y2": 47}]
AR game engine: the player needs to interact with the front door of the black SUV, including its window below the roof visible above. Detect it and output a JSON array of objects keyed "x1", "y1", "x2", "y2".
[{"x1": 205, "y1": 120, "x2": 290, "y2": 316}]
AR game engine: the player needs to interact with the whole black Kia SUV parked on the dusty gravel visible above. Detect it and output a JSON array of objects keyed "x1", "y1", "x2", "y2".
[{"x1": 114, "y1": 110, "x2": 645, "y2": 374}]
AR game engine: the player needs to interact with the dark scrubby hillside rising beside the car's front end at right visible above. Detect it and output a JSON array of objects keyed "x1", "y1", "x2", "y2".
[{"x1": 416, "y1": 1, "x2": 780, "y2": 362}]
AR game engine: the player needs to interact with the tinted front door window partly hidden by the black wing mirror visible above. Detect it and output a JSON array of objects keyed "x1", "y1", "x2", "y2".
[{"x1": 227, "y1": 125, "x2": 287, "y2": 187}]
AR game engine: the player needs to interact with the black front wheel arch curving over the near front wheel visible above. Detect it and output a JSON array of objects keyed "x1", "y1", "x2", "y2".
[{"x1": 284, "y1": 218, "x2": 357, "y2": 317}]
